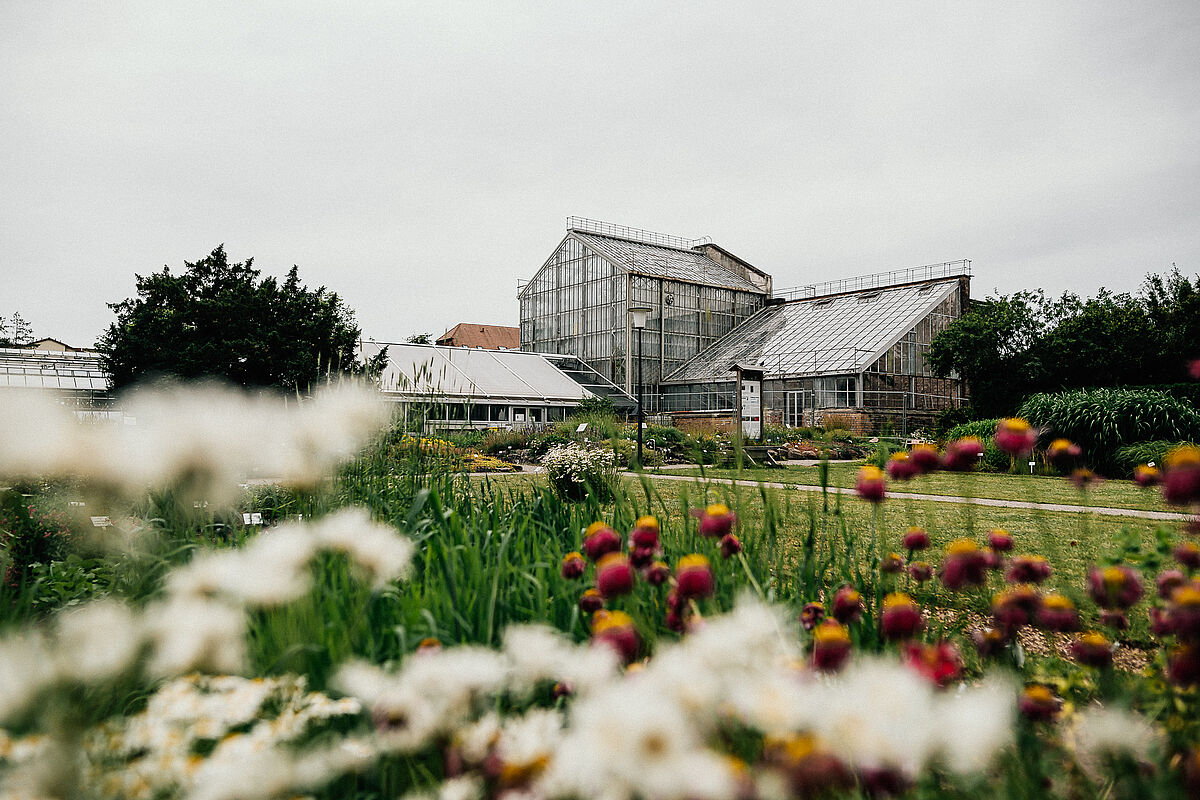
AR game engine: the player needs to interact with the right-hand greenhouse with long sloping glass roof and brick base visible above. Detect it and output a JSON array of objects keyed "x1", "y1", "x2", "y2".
[{"x1": 660, "y1": 261, "x2": 970, "y2": 433}]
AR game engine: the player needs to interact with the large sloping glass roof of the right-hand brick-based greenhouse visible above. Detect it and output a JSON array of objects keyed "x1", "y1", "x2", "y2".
[{"x1": 664, "y1": 281, "x2": 958, "y2": 384}]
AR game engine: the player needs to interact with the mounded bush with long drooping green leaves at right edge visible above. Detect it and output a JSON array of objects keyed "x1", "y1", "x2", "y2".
[{"x1": 1020, "y1": 389, "x2": 1200, "y2": 475}]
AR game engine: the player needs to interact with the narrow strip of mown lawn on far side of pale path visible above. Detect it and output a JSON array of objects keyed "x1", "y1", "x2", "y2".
[{"x1": 671, "y1": 463, "x2": 1180, "y2": 511}]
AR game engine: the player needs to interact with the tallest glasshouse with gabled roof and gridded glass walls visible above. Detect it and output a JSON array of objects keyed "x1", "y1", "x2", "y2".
[{"x1": 517, "y1": 217, "x2": 770, "y2": 410}]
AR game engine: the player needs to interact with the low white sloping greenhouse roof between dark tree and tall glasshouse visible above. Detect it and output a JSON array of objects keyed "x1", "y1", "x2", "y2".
[{"x1": 361, "y1": 342, "x2": 623, "y2": 403}]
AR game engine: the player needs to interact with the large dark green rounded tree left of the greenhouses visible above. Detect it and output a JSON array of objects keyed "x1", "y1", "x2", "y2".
[{"x1": 97, "y1": 245, "x2": 386, "y2": 392}]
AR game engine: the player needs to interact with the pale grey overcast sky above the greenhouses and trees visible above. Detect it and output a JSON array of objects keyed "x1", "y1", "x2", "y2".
[{"x1": 0, "y1": 0, "x2": 1200, "y2": 344}]
